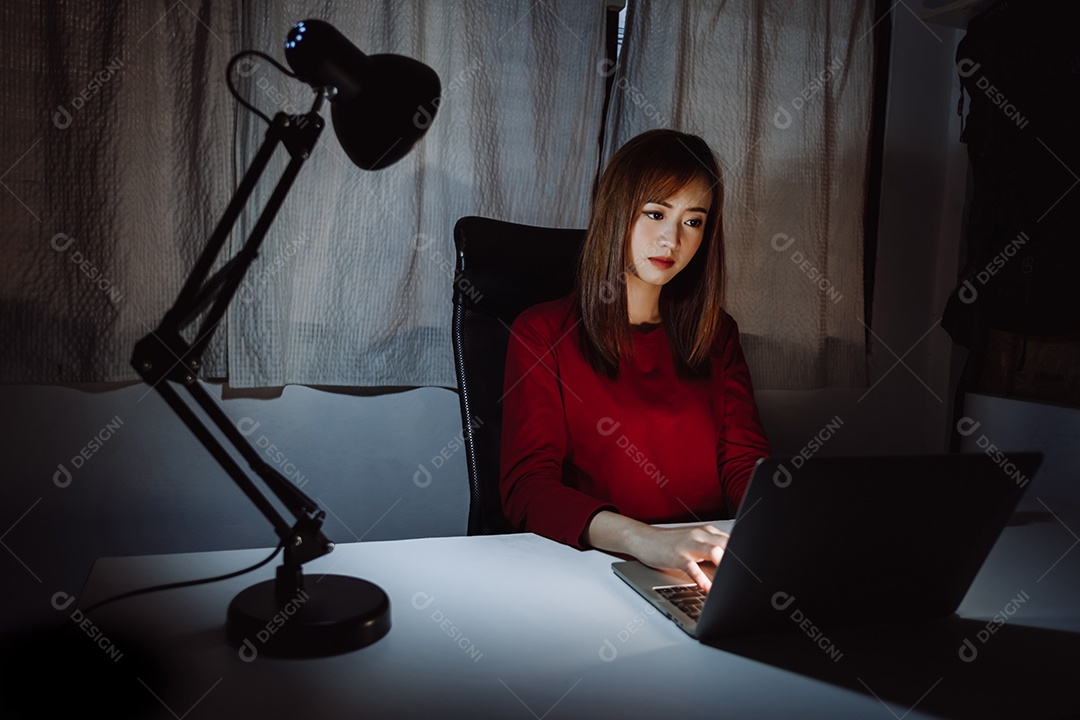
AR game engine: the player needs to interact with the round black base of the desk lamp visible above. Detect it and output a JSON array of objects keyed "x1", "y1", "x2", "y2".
[{"x1": 226, "y1": 575, "x2": 390, "y2": 662}]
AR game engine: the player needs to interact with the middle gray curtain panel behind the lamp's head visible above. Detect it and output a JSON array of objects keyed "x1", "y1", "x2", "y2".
[{"x1": 229, "y1": 0, "x2": 605, "y2": 386}]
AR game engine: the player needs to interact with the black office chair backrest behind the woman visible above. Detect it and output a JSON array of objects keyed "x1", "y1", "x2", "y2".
[{"x1": 453, "y1": 217, "x2": 585, "y2": 535}]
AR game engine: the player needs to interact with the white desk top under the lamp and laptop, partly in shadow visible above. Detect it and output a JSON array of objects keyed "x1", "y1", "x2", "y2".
[{"x1": 12, "y1": 498, "x2": 1080, "y2": 720}]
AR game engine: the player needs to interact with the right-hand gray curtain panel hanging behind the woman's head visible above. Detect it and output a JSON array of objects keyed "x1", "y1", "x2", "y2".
[{"x1": 607, "y1": 0, "x2": 874, "y2": 389}]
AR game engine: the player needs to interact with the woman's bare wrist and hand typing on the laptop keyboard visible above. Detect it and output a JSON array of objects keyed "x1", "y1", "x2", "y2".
[{"x1": 584, "y1": 511, "x2": 728, "y2": 593}]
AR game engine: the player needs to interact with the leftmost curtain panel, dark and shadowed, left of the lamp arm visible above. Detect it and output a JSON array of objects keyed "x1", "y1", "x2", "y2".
[{"x1": 0, "y1": 2, "x2": 239, "y2": 382}]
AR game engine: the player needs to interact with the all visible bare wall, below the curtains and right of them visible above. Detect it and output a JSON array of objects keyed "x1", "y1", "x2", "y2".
[{"x1": 0, "y1": 10, "x2": 964, "y2": 628}]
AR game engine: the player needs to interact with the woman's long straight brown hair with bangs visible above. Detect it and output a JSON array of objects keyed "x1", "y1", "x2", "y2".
[{"x1": 576, "y1": 130, "x2": 724, "y2": 378}]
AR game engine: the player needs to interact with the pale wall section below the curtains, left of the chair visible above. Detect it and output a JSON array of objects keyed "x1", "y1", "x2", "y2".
[{"x1": 0, "y1": 384, "x2": 469, "y2": 629}]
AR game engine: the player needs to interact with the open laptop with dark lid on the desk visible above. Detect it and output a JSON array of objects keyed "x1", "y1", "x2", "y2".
[{"x1": 611, "y1": 452, "x2": 1042, "y2": 642}]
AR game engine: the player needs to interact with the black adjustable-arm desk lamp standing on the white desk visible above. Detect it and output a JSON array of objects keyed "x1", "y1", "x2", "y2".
[{"x1": 132, "y1": 19, "x2": 441, "y2": 656}]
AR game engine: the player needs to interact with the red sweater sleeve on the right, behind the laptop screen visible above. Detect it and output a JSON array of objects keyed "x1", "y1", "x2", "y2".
[{"x1": 715, "y1": 317, "x2": 770, "y2": 507}]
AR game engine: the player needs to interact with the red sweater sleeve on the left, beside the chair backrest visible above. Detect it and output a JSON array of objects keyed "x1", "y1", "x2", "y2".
[{"x1": 500, "y1": 311, "x2": 616, "y2": 548}]
